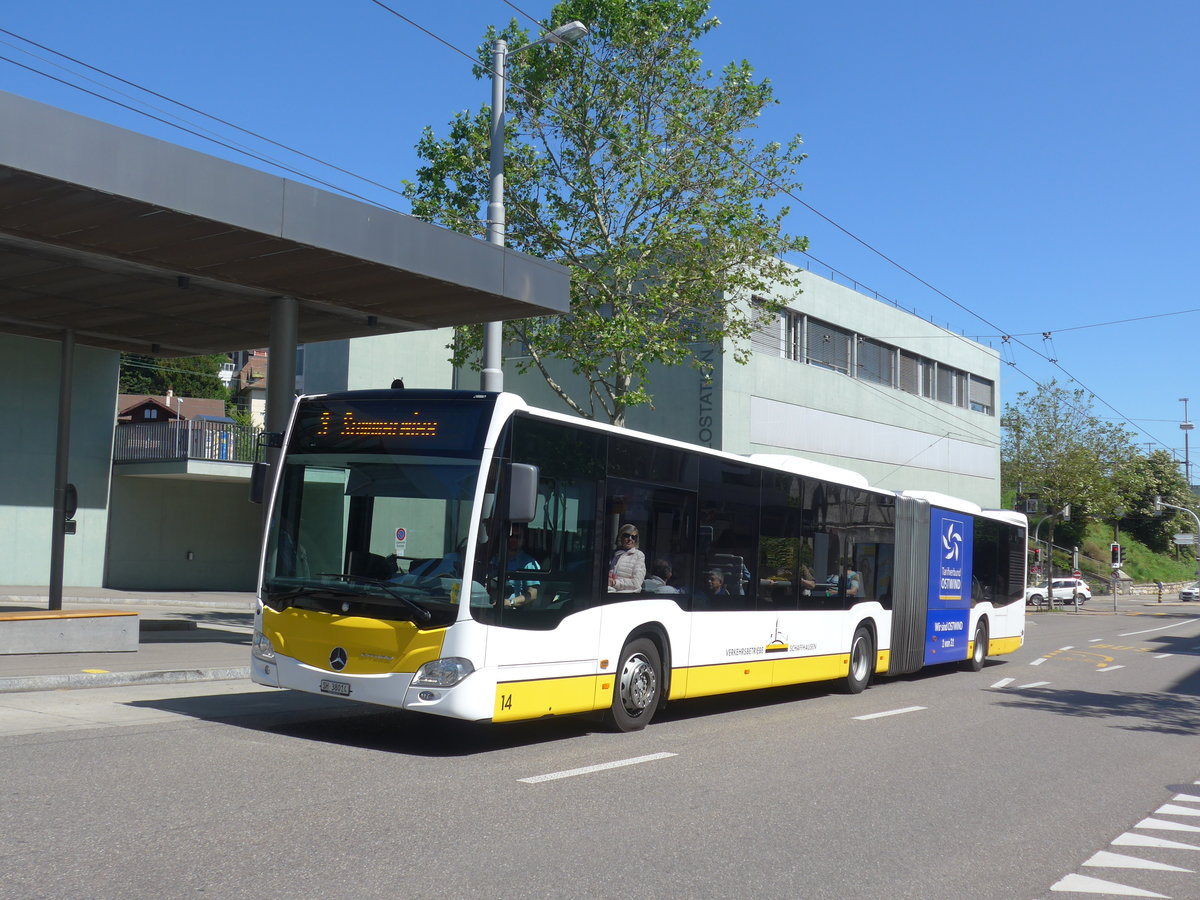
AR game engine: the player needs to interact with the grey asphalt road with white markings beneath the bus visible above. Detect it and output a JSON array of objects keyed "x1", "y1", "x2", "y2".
[{"x1": 0, "y1": 607, "x2": 1200, "y2": 900}]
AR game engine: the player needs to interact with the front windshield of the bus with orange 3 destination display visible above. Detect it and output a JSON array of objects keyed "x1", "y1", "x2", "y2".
[{"x1": 263, "y1": 400, "x2": 487, "y2": 626}]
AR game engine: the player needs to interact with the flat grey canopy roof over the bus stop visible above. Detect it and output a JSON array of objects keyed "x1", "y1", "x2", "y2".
[{"x1": 0, "y1": 92, "x2": 570, "y2": 356}]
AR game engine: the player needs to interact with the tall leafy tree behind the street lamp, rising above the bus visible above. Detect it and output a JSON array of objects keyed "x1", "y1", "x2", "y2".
[{"x1": 406, "y1": 0, "x2": 808, "y2": 425}]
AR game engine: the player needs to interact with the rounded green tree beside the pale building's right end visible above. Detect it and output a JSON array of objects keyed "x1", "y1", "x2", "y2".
[{"x1": 1001, "y1": 380, "x2": 1140, "y2": 542}]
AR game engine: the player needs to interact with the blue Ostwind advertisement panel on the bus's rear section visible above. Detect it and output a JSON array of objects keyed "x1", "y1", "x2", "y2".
[{"x1": 925, "y1": 506, "x2": 974, "y2": 666}]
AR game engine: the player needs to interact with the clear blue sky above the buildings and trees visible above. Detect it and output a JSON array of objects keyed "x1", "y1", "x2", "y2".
[{"x1": 0, "y1": 0, "x2": 1200, "y2": 478}]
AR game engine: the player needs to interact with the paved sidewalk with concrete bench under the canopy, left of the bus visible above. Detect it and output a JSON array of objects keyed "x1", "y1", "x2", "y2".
[{"x1": 0, "y1": 586, "x2": 254, "y2": 694}]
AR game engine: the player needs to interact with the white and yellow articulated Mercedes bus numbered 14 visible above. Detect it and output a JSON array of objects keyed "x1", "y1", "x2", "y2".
[{"x1": 251, "y1": 390, "x2": 1027, "y2": 731}]
